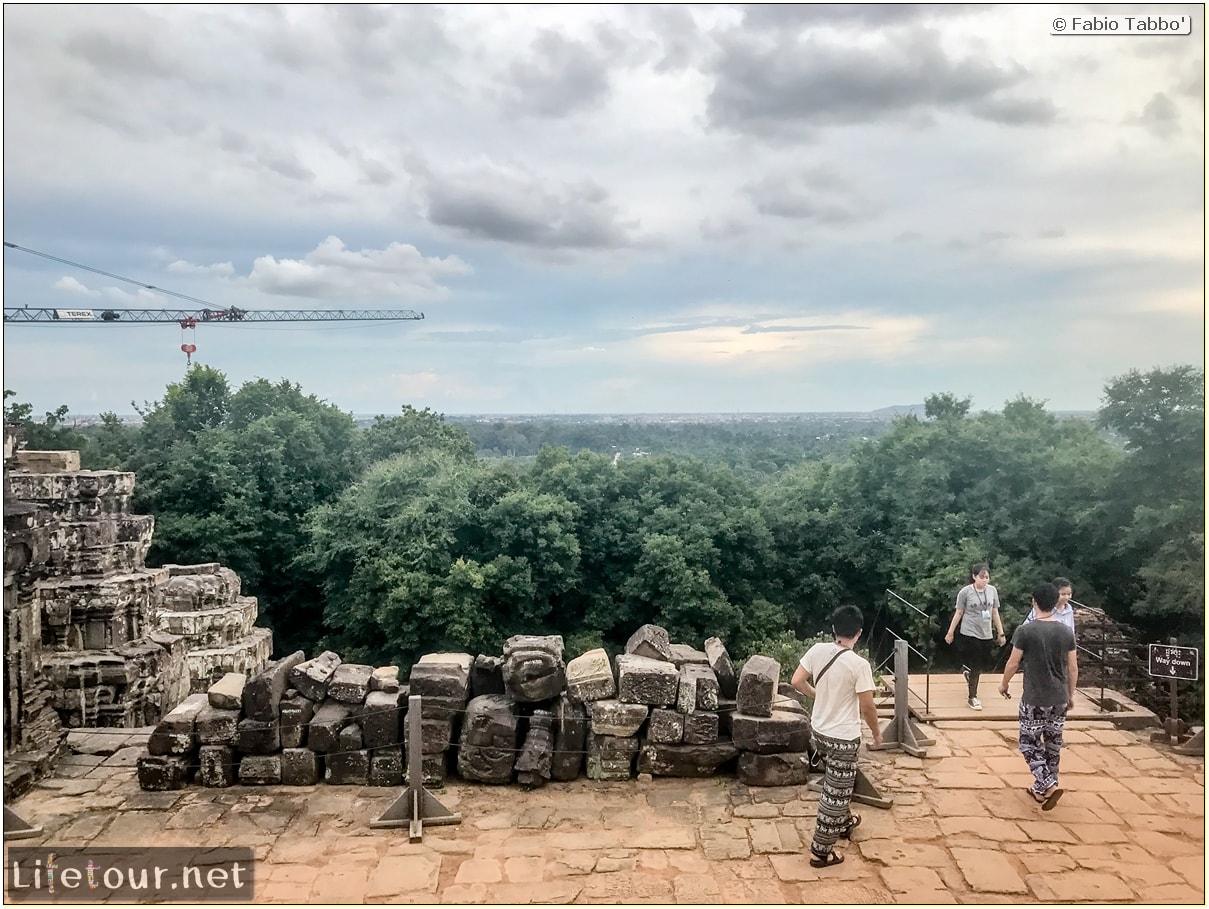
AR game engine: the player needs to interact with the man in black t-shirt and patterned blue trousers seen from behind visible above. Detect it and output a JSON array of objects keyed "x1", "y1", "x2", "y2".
[{"x1": 999, "y1": 583, "x2": 1078, "y2": 811}]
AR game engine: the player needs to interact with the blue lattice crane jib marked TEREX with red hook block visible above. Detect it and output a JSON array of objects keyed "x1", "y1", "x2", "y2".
[{"x1": 4, "y1": 306, "x2": 424, "y2": 365}]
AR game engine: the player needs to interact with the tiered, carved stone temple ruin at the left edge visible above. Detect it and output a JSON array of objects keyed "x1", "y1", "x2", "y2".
[{"x1": 4, "y1": 425, "x2": 272, "y2": 798}]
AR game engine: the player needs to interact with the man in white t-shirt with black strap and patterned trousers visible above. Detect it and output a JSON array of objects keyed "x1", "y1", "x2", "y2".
[{"x1": 789, "y1": 606, "x2": 881, "y2": 868}]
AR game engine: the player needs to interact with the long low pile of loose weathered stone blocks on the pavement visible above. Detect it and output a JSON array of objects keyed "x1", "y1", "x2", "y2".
[{"x1": 138, "y1": 625, "x2": 810, "y2": 789}]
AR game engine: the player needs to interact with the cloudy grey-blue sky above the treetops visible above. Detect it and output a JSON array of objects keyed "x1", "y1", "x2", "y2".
[{"x1": 4, "y1": 4, "x2": 1205, "y2": 413}]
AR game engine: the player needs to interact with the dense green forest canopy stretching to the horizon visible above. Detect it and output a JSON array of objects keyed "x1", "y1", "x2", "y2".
[{"x1": 5, "y1": 365, "x2": 1204, "y2": 691}]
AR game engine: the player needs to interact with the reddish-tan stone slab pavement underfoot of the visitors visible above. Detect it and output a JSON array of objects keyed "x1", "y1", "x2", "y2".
[{"x1": 8, "y1": 720, "x2": 1205, "y2": 905}]
